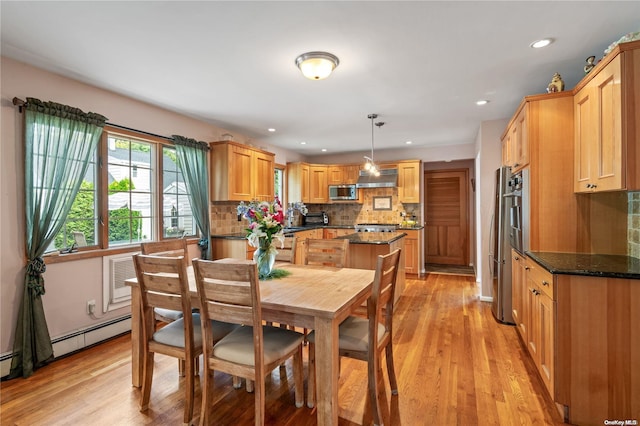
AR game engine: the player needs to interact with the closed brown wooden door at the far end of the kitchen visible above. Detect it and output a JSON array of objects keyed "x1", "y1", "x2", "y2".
[{"x1": 425, "y1": 169, "x2": 469, "y2": 266}]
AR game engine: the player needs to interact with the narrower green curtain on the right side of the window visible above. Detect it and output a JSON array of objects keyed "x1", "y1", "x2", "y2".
[{"x1": 172, "y1": 135, "x2": 211, "y2": 259}]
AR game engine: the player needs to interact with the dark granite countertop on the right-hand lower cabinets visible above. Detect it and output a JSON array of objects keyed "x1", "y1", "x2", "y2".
[{"x1": 526, "y1": 252, "x2": 640, "y2": 280}]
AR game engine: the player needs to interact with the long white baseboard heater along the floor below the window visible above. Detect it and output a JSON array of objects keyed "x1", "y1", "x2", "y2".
[{"x1": 0, "y1": 314, "x2": 131, "y2": 379}]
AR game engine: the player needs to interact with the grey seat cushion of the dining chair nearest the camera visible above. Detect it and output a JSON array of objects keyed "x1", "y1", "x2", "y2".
[{"x1": 213, "y1": 326, "x2": 303, "y2": 365}]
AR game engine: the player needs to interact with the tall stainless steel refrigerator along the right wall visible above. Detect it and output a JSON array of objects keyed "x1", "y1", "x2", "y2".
[{"x1": 489, "y1": 167, "x2": 513, "y2": 324}]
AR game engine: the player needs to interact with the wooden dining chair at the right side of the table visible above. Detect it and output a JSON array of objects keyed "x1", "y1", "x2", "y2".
[{"x1": 307, "y1": 248, "x2": 400, "y2": 425}]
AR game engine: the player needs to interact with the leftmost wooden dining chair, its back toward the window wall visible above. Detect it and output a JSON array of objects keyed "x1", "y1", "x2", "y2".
[{"x1": 133, "y1": 254, "x2": 202, "y2": 424}]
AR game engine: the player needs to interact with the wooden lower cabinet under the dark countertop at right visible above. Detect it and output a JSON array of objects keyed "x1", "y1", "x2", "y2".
[{"x1": 512, "y1": 253, "x2": 640, "y2": 425}]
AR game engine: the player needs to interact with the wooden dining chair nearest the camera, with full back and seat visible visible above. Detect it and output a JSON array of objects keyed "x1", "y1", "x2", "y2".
[{"x1": 193, "y1": 259, "x2": 304, "y2": 425}]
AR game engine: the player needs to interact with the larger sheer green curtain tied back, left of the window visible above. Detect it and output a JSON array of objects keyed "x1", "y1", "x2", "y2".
[{"x1": 9, "y1": 98, "x2": 107, "y2": 378}]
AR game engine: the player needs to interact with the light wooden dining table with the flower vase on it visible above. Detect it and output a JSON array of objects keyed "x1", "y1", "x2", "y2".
[{"x1": 125, "y1": 259, "x2": 375, "y2": 426}]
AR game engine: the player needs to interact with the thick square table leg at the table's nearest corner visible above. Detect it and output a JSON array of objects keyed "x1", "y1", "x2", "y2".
[{"x1": 315, "y1": 318, "x2": 340, "y2": 426}]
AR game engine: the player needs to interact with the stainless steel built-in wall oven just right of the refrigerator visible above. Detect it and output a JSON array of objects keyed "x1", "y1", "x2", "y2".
[{"x1": 505, "y1": 169, "x2": 529, "y2": 254}]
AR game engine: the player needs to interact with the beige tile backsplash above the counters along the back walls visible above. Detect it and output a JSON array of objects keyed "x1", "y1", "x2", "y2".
[{"x1": 211, "y1": 188, "x2": 422, "y2": 235}]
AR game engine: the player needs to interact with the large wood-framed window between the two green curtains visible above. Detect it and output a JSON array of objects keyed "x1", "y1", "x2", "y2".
[{"x1": 50, "y1": 127, "x2": 197, "y2": 250}]
